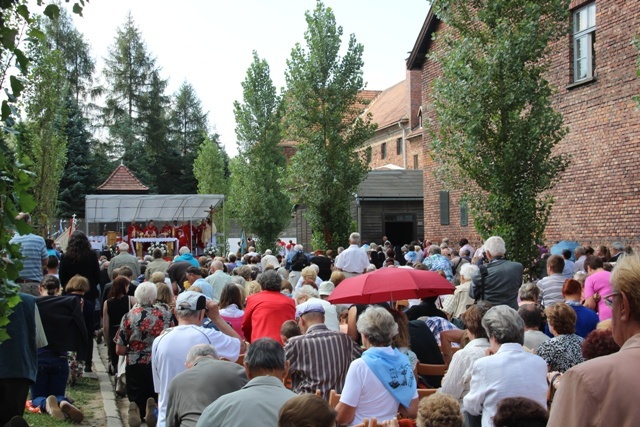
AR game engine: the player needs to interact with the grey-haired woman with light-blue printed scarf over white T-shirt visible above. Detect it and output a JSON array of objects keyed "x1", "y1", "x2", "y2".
[{"x1": 336, "y1": 307, "x2": 418, "y2": 425}]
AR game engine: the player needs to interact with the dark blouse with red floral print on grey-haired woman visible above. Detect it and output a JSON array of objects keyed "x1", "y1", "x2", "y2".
[{"x1": 116, "y1": 304, "x2": 175, "y2": 365}]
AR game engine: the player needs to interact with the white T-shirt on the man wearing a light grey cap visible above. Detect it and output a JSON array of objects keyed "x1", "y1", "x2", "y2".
[{"x1": 151, "y1": 325, "x2": 240, "y2": 427}]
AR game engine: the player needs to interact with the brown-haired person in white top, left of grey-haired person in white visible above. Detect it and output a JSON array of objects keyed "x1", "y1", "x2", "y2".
[{"x1": 439, "y1": 304, "x2": 491, "y2": 404}]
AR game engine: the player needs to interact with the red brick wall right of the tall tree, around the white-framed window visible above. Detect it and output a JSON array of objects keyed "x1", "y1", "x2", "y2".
[{"x1": 546, "y1": 0, "x2": 640, "y2": 245}]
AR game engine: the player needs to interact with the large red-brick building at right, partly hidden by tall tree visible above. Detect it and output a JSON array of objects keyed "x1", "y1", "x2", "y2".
[{"x1": 407, "y1": 0, "x2": 640, "y2": 251}]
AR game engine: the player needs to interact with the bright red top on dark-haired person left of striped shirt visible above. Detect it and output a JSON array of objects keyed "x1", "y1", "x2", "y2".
[{"x1": 242, "y1": 291, "x2": 296, "y2": 344}]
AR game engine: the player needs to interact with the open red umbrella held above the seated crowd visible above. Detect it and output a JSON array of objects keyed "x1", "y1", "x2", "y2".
[{"x1": 329, "y1": 267, "x2": 455, "y2": 304}]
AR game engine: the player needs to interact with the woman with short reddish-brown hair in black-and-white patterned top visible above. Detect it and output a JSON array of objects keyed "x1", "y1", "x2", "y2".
[{"x1": 538, "y1": 303, "x2": 584, "y2": 373}]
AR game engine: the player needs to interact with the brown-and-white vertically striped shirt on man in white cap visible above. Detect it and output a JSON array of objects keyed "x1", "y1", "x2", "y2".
[{"x1": 284, "y1": 323, "x2": 362, "y2": 399}]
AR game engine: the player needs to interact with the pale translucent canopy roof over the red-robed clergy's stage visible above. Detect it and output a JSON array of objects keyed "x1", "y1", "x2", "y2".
[{"x1": 85, "y1": 194, "x2": 224, "y2": 226}]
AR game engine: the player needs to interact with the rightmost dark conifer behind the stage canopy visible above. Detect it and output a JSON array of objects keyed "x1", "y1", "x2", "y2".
[{"x1": 169, "y1": 82, "x2": 209, "y2": 194}]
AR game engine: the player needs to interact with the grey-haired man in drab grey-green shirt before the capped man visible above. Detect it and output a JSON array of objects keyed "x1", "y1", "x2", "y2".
[{"x1": 167, "y1": 344, "x2": 248, "y2": 427}]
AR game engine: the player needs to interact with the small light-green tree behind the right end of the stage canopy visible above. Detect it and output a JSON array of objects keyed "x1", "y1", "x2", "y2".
[{"x1": 193, "y1": 134, "x2": 228, "y2": 194}]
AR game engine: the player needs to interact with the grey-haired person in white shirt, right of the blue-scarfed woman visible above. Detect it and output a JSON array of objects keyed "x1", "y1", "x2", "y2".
[{"x1": 463, "y1": 305, "x2": 548, "y2": 427}]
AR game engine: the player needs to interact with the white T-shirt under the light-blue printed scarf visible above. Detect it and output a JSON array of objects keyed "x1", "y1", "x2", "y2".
[{"x1": 340, "y1": 347, "x2": 418, "y2": 425}]
